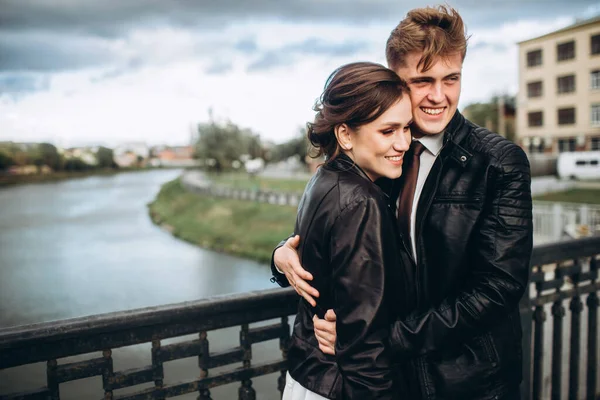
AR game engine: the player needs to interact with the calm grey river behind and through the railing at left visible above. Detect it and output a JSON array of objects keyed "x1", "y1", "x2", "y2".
[{"x1": 0, "y1": 170, "x2": 277, "y2": 399}]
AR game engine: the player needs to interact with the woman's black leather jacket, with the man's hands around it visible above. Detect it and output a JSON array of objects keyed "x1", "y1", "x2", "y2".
[{"x1": 276, "y1": 155, "x2": 415, "y2": 399}]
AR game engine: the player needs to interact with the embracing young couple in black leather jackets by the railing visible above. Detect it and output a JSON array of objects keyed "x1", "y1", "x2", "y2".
[{"x1": 272, "y1": 6, "x2": 532, "y2": 400}]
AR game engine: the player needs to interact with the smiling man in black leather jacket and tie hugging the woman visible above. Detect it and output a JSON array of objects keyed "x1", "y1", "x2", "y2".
[{"x1": 272, "y1": 6, "x2": 532, "y2": 400}]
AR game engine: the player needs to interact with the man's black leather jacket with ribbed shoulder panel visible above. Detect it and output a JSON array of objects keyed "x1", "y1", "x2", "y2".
[{"x1": 274, "y1": 112, "x2": 532, "y2": 400}]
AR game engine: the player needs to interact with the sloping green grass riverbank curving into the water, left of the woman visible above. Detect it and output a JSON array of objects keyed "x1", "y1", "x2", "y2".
[{"x1": 149, "y1": 179, "x2": 296, "y2": 262}]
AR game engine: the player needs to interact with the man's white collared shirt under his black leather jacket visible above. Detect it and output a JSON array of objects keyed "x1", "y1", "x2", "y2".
[{"x1": 404, "y1": 132, "x2": 444, "y2": 260}]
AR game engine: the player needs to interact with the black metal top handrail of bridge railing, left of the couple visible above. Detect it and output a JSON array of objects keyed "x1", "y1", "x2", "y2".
[{"x1": 0, "y1": 288, "x2": 298, "y2": 369}]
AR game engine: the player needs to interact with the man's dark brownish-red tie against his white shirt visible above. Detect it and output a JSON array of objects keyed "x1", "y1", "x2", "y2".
[{"x1": 398, "y1": 140, "x2": 425, "y2": 246}]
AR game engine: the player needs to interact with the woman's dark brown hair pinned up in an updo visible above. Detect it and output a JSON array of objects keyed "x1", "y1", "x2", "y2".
[{"x1": 306, "y1": 62, "x2": 408, "y2": 160}]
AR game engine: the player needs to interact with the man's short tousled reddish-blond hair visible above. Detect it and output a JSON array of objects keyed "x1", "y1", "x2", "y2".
[{"x1": 385, "y1": 5, "x2": 469, "y2": 71}]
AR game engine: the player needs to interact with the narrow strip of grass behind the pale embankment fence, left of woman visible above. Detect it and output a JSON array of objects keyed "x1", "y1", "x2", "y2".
[{"x1": 209, "y1": 173, "x2": 307, "y2": 193}]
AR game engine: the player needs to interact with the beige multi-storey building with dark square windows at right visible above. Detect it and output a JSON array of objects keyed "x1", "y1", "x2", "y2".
[{"x1": 517, "y1": 16, "x2": 600, "y2": 154}]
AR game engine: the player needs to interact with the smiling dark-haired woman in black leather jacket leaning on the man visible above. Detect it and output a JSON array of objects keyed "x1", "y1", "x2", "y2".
[{"x1": 283, "y1": 62, "x2": 412, "y2": 400}]
